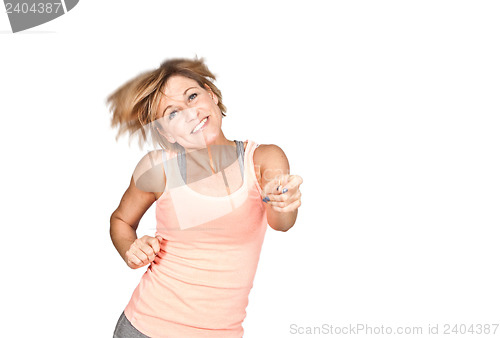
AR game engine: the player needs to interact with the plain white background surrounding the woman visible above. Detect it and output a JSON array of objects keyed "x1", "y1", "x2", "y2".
[{"x1": 0, "y1": 1, "x2": 500, "y2": 338}]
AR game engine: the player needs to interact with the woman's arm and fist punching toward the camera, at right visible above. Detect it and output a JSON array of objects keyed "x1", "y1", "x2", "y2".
[{"x1": 254, "y1": 144, "x2": 302, "y2": 231}]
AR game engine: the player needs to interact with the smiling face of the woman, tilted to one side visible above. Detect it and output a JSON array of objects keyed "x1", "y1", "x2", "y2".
[{"x1": 157, "y1": 75, "x2": 222, "y2": 149}]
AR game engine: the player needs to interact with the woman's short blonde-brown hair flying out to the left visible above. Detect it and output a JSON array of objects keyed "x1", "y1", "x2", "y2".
[{"x1": 106, "y1": 58, "x2": 226, "y2": 149}]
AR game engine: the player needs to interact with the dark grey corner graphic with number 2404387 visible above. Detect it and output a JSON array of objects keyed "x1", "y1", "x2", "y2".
[{"x1": 4, "y1": 0, "x2": 78, "y2": 33}]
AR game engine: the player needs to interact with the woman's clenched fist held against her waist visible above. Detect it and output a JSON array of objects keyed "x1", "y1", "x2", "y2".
[{"x1": 125, "y1": 235, "x2": 163, "y2": 269}]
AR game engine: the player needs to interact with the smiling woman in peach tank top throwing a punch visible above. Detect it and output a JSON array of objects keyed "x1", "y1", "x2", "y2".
[{"x1": 108, "y1": 59, "x2": 302, "y2": 338}]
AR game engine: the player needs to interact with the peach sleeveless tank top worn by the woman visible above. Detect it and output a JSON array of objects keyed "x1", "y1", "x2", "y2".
[{"x1": 124, "y1": 141, "x2": 267, "y2": 338}]
